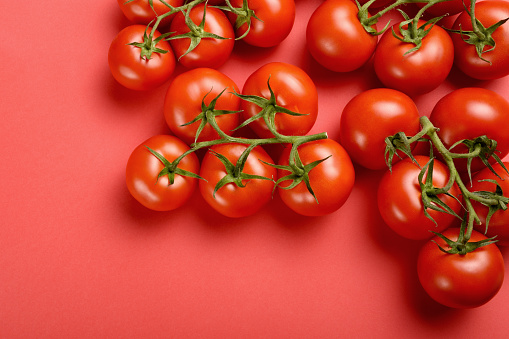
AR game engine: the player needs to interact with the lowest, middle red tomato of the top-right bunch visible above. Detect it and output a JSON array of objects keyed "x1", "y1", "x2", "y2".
[{"x1": 374, "y1": 20, "x2": 454, "y2": 97}]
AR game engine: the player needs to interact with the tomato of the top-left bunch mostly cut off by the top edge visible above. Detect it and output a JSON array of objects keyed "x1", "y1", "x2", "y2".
[{"x1": 117, "y1": 0, "x2": 184, "y2": 27}]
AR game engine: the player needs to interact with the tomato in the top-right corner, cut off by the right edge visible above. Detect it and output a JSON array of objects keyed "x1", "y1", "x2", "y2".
[{"x1": 451, "y1": 1, "x2": 509, "y2": 80}]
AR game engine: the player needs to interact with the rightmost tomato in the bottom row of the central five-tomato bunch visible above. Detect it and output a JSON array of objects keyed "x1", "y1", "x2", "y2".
[{"x1": 278, "y1": 139, "x2": 355, "y2": 216}]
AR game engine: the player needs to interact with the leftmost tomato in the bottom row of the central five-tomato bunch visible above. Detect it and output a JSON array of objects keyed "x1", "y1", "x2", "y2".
[{"x1": 126, "y1": 135, "x2": 200, "y2": 211}]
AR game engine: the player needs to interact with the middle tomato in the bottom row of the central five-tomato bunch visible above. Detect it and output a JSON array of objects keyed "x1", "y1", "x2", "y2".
[{"x1": 199, "y1": 143, "x2": 277, "y2": 218}]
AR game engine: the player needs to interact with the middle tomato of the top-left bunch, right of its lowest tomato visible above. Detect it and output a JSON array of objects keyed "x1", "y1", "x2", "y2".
[{"x1": 170, "y1": 4, "x2": 235, "y2": 68}]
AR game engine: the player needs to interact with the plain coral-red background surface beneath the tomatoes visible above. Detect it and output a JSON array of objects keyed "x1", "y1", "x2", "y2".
[{"x1": 0, "y1": 0, "x2": 509, "y2": 338}]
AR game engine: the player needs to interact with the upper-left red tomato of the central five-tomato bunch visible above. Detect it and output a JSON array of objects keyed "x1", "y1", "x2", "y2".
[{"x1": 164, "y1": 68, "x2": 240, "y2": 144}]
